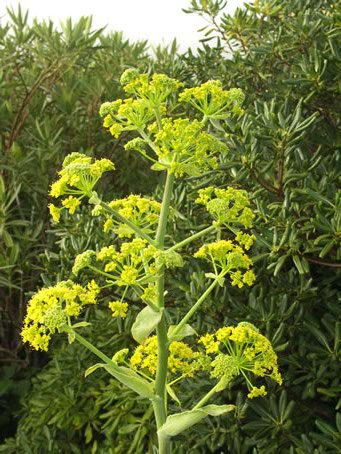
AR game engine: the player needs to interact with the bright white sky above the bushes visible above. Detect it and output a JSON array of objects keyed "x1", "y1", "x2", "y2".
[{"x1": 0, "y1": 0, "x2": 244, "y2": 50}]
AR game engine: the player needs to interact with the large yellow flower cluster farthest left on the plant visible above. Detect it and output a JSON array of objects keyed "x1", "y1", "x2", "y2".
[{"x1": 21, "y1": 281, "x2": 99, "y2": 351}]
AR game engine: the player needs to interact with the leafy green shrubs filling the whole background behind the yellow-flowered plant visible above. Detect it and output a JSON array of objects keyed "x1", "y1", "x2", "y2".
[{"x1": 0, "y1": 0, "x2": 341, "y2": 454}]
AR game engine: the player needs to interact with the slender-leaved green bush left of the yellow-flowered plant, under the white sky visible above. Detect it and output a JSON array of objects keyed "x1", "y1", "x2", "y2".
[{"x1": 0, "y1": 4, "x2": 150, "y2": 435}]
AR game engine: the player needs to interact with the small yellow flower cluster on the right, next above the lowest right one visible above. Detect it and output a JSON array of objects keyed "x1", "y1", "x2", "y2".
[{"x1": 194, "y1": 240, "x2": 256, "y2": 288}]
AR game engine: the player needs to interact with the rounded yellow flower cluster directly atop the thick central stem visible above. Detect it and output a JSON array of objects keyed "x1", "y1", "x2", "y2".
[{"x1": 149, "y1": 118, "x2": 227, "y2": 177}]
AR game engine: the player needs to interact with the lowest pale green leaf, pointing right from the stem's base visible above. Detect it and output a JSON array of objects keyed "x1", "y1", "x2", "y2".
[{"x1": 158, "y1": 405, "x2": 235, "y2": 438}]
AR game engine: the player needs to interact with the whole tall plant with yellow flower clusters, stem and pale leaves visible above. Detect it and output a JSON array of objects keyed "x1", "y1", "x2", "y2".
[{"x1": 22, "y1": 70, "x2": 282, "y2": 454}]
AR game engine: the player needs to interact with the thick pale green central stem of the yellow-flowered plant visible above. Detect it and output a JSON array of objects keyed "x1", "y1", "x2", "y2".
[{"x1": 153, "y1": 174, "x2": 174, "y2": 454}]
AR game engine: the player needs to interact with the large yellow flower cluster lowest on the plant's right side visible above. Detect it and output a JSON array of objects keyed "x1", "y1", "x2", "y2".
[{"x1": 199, "y1": 322, "x2": 282, "y2": 398}]
